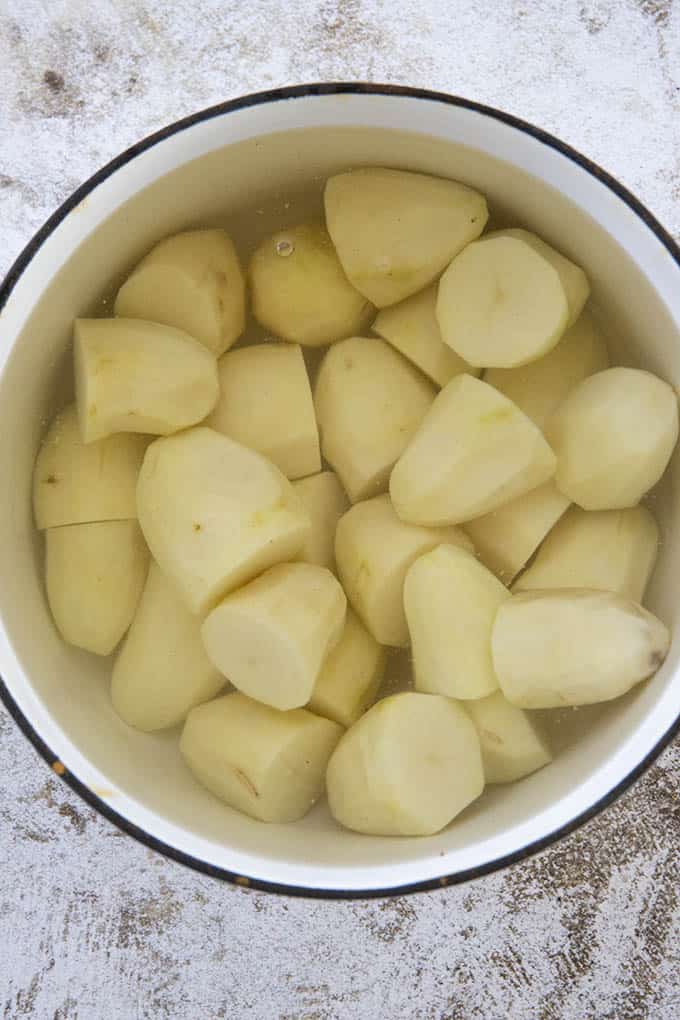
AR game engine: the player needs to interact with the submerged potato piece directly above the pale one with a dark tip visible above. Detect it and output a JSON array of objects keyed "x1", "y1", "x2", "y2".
[{"x1": 513, "y1": 506, "x2": 659, "y2": 602}]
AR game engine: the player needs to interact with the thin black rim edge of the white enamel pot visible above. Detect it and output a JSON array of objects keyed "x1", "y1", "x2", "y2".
[{"x1": 0, "y1": 82, "x2": 680, "y2": 900}]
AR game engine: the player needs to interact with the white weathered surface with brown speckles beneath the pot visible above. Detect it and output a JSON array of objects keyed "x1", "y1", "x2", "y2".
[{"x1": 0, "y1": 0, "x2": 680, "y2": 1020}]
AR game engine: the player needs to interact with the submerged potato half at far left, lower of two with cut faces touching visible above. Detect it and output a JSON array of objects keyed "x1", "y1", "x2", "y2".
[{"x1": 45, "y1": 520, "x2": 149, "y2": 655}]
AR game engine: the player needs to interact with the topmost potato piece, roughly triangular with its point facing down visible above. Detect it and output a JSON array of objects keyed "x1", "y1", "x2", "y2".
[{"x1": 324, "y1": 167, "x2": 488, "y2": 308}]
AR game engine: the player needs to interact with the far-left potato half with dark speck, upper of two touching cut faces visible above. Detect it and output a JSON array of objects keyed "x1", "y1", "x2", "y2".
[{"x1": 33, "y1": 404, "x2": 149, "y2": 530}]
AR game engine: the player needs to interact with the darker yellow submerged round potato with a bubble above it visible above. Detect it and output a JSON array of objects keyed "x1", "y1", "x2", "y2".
[{"x1": 249, "y1": 223, "x2": 373, "y2": 347}]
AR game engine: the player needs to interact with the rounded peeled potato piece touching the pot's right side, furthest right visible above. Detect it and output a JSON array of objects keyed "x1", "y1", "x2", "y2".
[{"x1": 545, "y1": 367, "x2": 678, "y2": 510}]
